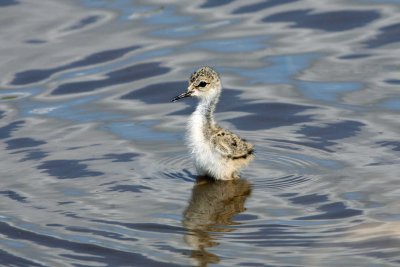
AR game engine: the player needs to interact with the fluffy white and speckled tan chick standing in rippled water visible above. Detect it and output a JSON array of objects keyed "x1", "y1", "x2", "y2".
[{"x1": 172, "y1": 67, "x2": 254, "y2": 180}]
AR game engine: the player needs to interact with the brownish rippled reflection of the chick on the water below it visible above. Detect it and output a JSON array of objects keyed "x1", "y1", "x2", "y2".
[{"x1": 182, "y1": 177, "x2": 251, "y2": 266}]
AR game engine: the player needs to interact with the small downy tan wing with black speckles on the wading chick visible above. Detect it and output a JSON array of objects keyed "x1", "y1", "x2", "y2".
[{"x1": 211, "y1": 130, "x2": 254, "y2": 159}]
